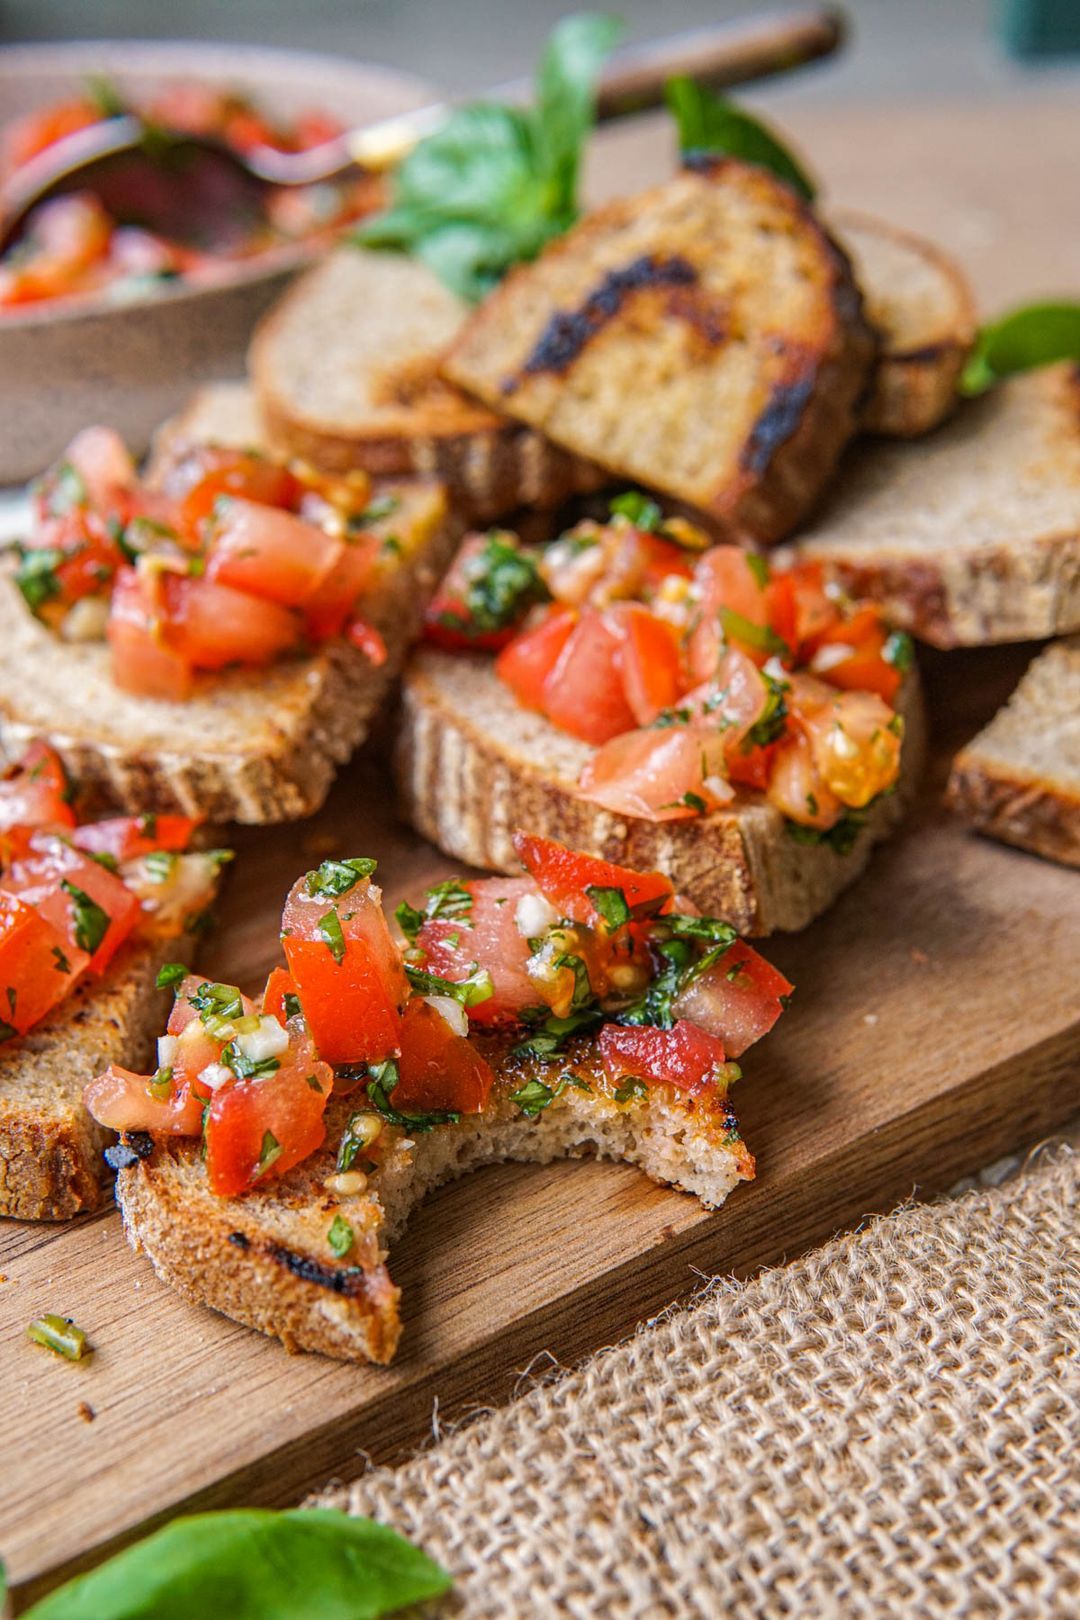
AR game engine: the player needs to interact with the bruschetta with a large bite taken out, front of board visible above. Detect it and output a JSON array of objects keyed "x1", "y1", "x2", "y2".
[{"x1": 86, "y1": 834, "x2": 792, "y2": 1362}]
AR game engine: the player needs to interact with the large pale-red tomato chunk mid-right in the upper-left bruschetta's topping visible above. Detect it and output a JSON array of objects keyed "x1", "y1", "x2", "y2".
[{"x1": 207, "y1": 492, "x2": 347, "y2": 608}]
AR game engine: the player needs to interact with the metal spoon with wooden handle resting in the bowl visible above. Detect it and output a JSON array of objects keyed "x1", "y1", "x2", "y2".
[{"x1": 0, "y1": 6, "x2": 844, "y2": 251}]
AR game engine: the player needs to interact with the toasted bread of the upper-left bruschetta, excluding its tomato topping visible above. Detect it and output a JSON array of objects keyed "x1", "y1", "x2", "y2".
[{"x1": 0, "y1": 390, "x2": 457, "y2": 821}]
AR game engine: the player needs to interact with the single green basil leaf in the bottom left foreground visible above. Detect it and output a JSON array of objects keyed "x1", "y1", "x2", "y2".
[{"x1": 28, "y1": 1508, "x2": 452, "y2": 1620}]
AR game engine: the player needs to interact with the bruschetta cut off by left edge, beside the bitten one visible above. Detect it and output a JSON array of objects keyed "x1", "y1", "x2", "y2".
[{"x1": 0, "y1": 742, "x2": 228, "y2": 1220}]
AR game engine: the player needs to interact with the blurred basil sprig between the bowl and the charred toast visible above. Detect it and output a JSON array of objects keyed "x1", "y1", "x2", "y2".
[{"x1": 356, "y1": 13, "x2": 620, "y2": 301}]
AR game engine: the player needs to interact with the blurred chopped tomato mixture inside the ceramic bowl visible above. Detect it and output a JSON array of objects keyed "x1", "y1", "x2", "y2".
[{"x1": 0, "y1": 79, "x2": 382, "y2": 316}]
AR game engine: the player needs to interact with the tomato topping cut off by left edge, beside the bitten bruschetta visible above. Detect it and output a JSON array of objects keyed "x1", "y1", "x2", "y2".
[{"x1": 0, "y1": 742, "x2": 228, "y2": 1051}]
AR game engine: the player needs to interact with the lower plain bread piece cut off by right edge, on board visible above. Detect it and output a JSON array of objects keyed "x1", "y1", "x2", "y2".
[{"x1": 947, "y1": 637, "x2": 1080, "y2": 867}]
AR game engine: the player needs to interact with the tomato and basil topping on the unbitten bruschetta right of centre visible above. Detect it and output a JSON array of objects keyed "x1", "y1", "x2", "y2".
[{"x1": 426, "y1": 491, "x2": 913, "y2": 851}]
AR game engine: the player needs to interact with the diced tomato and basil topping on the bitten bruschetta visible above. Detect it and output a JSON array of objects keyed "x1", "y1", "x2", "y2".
[{"x1": 86, "y1": 833, "x2": 792, "y2": 1205}]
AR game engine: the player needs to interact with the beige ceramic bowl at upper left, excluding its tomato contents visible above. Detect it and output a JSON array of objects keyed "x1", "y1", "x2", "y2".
[{"x1": 0, "y1": 41, "x2": 431, "y2": 484}]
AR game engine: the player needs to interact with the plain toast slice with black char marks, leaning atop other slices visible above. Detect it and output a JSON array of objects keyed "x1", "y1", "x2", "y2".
[{"x1": 444, "y1": 159, "x2": 874, "y2": 541}]
